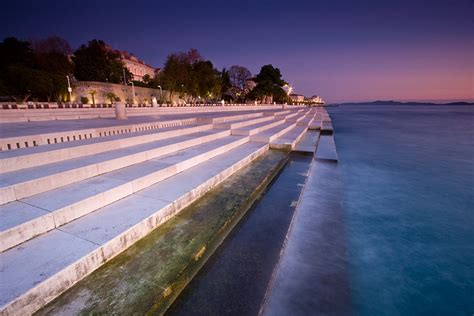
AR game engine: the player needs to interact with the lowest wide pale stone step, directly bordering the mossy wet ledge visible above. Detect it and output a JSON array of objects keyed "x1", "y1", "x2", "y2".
[{"x1": 0, "y1": 142, "x2": 268, "y2": 315}]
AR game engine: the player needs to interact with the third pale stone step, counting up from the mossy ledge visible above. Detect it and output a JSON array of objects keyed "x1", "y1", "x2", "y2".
[{"x1": 0, "y1": 130, "x2": 230, "y2": 204}]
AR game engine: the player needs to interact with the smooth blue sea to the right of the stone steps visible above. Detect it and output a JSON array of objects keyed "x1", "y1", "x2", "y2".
[{"x1": 328, "y1": 105, "x2": 474, "y2": 315}]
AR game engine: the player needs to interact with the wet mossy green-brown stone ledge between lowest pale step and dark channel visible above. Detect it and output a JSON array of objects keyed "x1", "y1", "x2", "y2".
[{"x1": 37, "y1": 151, "x2": 287, "y2": 315}]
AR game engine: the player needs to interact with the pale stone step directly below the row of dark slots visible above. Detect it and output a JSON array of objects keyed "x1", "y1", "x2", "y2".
[{"x1": 0, "y1": 124, "x2": 212, "y2": 173}]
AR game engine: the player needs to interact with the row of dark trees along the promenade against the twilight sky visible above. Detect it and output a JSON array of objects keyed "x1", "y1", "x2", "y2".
[{"x1": 0, "y1": 37, "x2": 288, "y2": 103}]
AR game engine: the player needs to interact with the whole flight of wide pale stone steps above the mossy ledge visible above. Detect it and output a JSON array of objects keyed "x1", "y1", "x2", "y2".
[{"x1": 0, "y1": 108, "x2": 329, "y2": 315}]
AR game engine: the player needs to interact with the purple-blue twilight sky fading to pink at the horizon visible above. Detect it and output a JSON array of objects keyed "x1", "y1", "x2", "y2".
[{"x1": 0, "y1": 0, "x2": 474, "y2": 102}]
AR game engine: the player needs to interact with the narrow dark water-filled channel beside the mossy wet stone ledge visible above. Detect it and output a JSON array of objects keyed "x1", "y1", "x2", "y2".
[{"x1": 167, "y1": 154, "x2": 312, "y2": 315}]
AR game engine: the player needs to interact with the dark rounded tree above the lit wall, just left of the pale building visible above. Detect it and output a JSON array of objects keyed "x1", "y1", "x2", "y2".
[{"x1": 73, "y1": 40, "x2": 126, "y2": 83}]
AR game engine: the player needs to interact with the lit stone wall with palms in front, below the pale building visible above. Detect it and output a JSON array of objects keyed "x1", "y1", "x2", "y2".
[{"x1": 72, "y1": 81, "x2": 179, "y2": 104}]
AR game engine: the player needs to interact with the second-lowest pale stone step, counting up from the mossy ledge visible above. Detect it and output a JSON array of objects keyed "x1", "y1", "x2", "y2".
[{"x1": 0, "y1": 131, "x2": 249, "y2": 251}]
